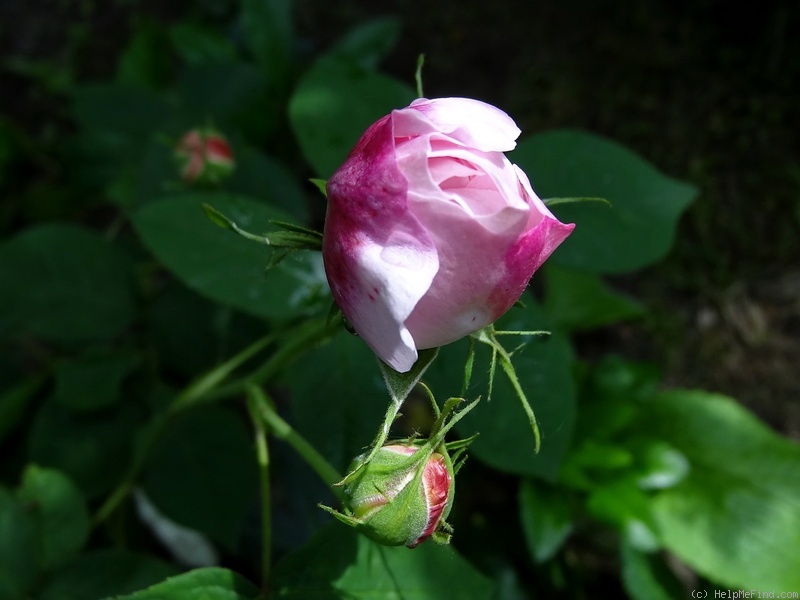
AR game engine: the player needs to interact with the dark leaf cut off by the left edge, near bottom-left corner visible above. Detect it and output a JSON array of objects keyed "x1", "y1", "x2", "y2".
[{"x1": 0, "y1": 487, "x2": 39, "y2": 600}]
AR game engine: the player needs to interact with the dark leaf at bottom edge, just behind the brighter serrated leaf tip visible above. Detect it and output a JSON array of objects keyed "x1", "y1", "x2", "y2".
[{"x1": 37, "y1": 549, "x2": 177, "y2": 600}]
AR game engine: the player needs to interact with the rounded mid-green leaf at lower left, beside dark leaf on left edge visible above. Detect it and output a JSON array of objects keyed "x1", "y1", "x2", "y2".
[{"x1": 17, "y1": 465, "x2": 89, "y2": 569}]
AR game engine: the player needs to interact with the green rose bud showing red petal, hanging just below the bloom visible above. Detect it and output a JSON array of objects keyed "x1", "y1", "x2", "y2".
[{"x1": 331, "y1": 444, "x2": 454, "y2": 548}]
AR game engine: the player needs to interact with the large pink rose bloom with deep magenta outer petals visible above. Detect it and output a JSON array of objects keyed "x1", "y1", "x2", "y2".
[{"x1": 323, "y1": 98, "x2": 574, "y2": 372}]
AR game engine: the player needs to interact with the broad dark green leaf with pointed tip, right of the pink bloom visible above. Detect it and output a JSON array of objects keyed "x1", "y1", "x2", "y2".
[{"x1": 511, "y1": 131, "x2": 697, "y2": 273}]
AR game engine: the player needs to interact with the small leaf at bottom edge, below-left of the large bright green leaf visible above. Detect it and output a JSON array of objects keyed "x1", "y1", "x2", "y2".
[{"x1": 620, "y1": 543, "x2": 686, "y2": 600}]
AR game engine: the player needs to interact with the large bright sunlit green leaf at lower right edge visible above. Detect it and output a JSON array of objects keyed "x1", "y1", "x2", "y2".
[{"x1": 642, "y1": 391, "x2": 800, "y2": 591}]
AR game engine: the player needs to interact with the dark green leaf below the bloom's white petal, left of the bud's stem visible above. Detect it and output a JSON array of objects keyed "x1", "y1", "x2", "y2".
[{"x1": 284, "y1": 332, "x2": 389, "y2": 472}]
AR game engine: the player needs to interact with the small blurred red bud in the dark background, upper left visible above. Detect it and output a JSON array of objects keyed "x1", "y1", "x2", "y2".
[{"x1": 175, "y1": 128, "x2": 235, "y2": 185}]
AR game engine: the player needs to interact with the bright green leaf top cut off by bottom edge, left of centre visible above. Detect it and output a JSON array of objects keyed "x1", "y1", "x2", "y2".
[{"x1": 107, "y1": 567, "x2": 258, "y2": 600}]
